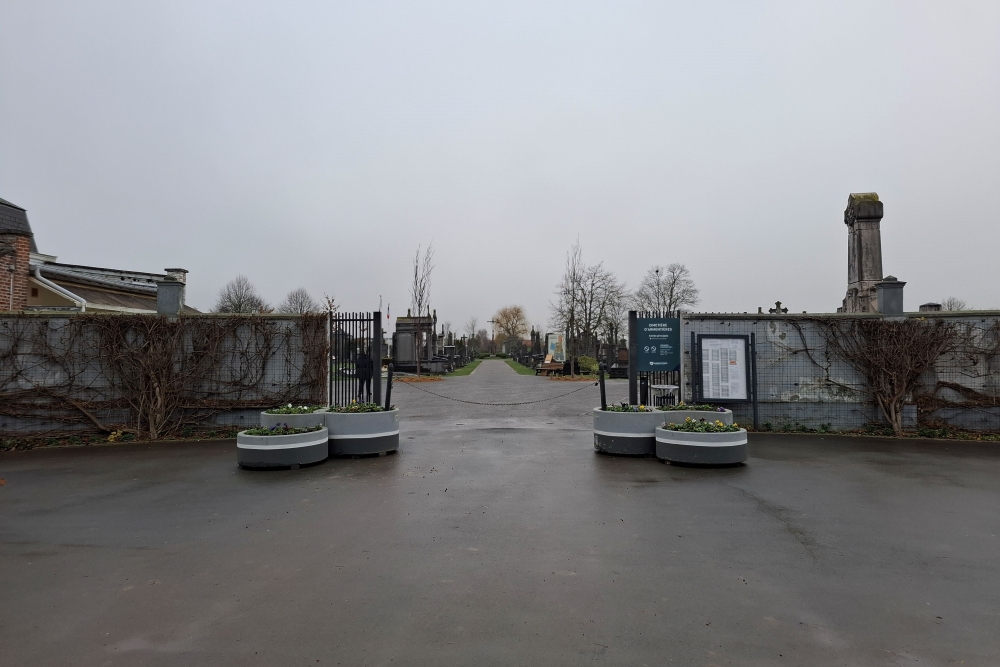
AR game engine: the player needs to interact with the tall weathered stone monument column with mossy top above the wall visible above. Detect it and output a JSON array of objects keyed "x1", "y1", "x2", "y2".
[{"x1": 842, "y1": 192, "x2": 882, "y2": 313}]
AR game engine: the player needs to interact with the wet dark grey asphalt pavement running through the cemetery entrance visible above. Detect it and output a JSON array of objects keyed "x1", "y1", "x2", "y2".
[{"x1": 0, "y1": 361, "x2": 1000, "y2": 666}]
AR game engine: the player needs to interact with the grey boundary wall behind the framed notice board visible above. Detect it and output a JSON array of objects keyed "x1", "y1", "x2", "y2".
[{"x1": 681, "y1": 311, "x2": 1000, "y2": 431}]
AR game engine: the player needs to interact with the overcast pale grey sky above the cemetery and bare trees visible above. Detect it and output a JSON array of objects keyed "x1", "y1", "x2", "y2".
[{"x1": 0, "y1": 0, "x2": 1000, "y2": 326}]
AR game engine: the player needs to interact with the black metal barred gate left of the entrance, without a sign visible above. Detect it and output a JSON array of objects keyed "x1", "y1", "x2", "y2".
[{"x1": 327, "y1": 311, "x2": 382, "y2": 405}]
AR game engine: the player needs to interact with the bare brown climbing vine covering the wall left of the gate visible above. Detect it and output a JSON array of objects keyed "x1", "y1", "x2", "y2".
[{"x1": 0, "y1": 315, "x2": 328, "y2": 439}]
